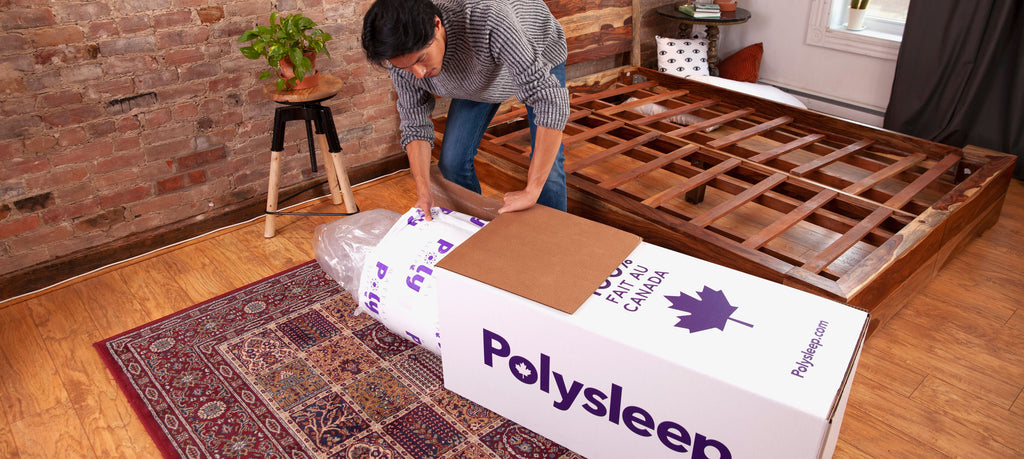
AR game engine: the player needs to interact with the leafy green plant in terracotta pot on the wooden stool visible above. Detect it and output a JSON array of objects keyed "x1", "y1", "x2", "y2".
[{"x1": 239, "y1": 12, "x2": 332, "y2": 90}]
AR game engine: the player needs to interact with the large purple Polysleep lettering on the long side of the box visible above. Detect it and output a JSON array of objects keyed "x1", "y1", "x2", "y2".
[{"x1": 483, "y1": 329, "x2": 732, "y2": 459}]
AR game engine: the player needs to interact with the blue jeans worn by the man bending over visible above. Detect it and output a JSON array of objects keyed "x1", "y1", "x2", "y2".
[{"x1": 437, "y1": 62, "x2": 566, "y2": 212}]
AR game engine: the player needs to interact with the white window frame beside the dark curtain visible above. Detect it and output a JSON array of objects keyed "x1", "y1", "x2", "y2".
[{"x1": 805, "y1": 0, "x2": 903, "y2": 60}]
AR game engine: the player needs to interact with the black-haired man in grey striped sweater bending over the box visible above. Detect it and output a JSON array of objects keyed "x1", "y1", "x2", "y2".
[{"x1": 362, "y1": 0, "x2": 569, "y2": 218}]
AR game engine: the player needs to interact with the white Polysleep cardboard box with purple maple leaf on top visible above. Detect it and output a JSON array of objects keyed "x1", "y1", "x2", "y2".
[{"x1": 437, "y1": 205, "x2": 868, "y2": 458}]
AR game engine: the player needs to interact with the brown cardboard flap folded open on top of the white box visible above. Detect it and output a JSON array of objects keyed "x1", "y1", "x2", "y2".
[{"x1": 437, "y1": 205, "x2": 641, "y2": 314}]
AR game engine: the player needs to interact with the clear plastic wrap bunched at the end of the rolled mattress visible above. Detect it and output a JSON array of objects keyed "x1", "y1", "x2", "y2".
[{"x1": 313, "y1": 209, "x2": 401, "y2": 295}]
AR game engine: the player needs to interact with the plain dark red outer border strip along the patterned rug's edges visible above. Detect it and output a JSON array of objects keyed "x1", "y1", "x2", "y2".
[{"x1": 92, "y1": 259, "x2": 316, "y2": 458}]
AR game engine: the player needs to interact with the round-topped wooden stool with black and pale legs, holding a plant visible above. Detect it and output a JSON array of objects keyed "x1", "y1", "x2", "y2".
[{"x1": 263, "y1": 75, "x2": 358, "y2": 238}]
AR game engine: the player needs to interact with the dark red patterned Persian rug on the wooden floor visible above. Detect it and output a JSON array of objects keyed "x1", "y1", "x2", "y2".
[{"x1": 95, "y1": 262, "x2": 581, "y2": 458}]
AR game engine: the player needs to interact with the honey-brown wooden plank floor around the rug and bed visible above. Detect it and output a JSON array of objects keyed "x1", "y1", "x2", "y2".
[{"x1": 0, "y1": 173, "x2": 1024, "y2": 458}]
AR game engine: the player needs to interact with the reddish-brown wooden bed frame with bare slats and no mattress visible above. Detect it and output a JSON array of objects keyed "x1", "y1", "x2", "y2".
[{"x1": 436, "y1": 1, "x2": 1016, "y2": 331}]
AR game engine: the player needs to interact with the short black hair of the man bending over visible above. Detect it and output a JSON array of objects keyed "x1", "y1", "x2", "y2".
[{"x1": 361, "y1": 0, "x2": 441, "y2": 67}]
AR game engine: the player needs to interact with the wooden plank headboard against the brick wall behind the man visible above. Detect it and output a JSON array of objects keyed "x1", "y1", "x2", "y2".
[{"x1": 545, "y1": 0, "x2": 633, "y2": 67}]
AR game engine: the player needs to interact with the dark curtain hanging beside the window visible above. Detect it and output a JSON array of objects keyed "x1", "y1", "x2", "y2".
[{"x1": 885, "y1": 0, "x2": 1024, "y2": 179}]
